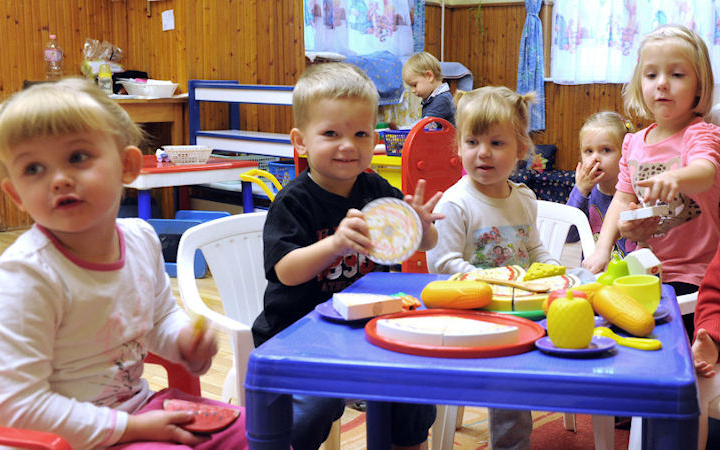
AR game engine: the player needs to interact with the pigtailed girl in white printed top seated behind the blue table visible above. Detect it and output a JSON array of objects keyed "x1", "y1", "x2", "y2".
[{"x1": 426, "y1": 86, "x2": 559, "y2": 448}]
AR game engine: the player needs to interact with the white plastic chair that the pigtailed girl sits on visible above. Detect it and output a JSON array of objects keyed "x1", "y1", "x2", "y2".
[{"x1": 432, "y1": 200, "x2": 615, "y2": 450}]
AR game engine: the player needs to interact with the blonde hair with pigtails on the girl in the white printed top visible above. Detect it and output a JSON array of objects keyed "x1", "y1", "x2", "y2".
[{"x1": 455, "y1": 86, "x2": 535, "y2": 155}]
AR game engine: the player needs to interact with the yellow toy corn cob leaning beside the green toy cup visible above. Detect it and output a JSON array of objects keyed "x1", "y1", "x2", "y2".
[{"x1": 592, "y1": 286, "x2": 655, "y2": 337}]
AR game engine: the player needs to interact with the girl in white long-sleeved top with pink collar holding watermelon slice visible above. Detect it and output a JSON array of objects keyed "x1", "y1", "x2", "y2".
[{"x1": 0, "y1": 79, "x2": 247, "y2": 448}]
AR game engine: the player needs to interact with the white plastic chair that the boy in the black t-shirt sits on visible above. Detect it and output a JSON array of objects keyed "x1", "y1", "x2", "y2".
[{"x1": 177, "y1": 211, "x2": 340, "y2": 449}]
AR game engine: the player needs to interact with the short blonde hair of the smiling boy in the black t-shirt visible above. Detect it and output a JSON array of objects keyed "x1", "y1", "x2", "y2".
[{"x1": 293, "y1": 63, "x2": 379, "y2": 128}]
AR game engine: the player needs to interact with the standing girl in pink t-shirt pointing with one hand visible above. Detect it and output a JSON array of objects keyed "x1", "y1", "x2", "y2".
[{"x1": 583, "y1": 26, "x2": 720, "y2": 308}]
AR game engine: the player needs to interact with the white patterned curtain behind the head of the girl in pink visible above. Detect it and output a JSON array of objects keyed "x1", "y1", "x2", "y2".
[{"x1": 551, "y1": 0, "x2": 720, "y2": 84}]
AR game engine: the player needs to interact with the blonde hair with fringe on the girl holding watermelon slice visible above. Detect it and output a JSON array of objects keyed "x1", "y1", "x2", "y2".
[{"x1": 0, "y1": 78, "x2": 144, "y2": 168}]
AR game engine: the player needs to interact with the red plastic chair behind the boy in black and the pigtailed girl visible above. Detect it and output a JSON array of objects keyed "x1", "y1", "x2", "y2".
[{"x1": 400, "y1": 117, "x2": 462, "y2": 273}]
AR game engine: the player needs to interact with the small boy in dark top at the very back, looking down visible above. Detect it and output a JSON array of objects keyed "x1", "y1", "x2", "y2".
[{"x1": 402, "y1": 52, "x2": 455, "y2": 126}]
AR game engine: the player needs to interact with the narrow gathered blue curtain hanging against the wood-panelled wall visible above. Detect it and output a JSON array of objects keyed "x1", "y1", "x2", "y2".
[{"x1": 517, "y1": 0, "x2": 545, "y2": 131}]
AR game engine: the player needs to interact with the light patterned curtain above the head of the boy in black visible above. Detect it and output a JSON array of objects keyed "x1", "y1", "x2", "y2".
[{"x1": 303, "y1": 0, "x2": 425, "y2": 56}]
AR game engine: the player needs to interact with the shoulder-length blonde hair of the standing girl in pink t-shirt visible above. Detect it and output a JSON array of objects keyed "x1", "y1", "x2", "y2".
[{"x1": 622, "y1": 25, "x2": 714, "y2": 120}]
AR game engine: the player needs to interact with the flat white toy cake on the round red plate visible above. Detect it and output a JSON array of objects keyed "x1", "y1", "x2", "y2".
[{"x1": 377, "y1": 315, "x2": 519, "y2": 347}]
